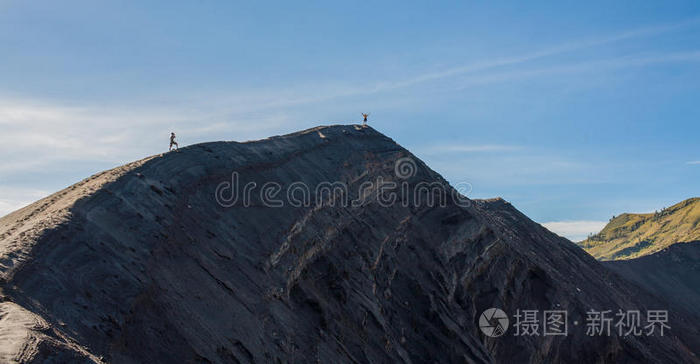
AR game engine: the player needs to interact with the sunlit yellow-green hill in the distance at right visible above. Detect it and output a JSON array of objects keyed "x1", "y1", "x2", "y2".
[{"x1": 578, "y1": 197, "x2": 700, "y2": 260}]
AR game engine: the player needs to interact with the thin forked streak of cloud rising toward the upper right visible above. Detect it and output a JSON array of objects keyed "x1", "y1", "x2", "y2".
[{"x1": 205, "y1": 18, "x2": 700, "y2": 111}]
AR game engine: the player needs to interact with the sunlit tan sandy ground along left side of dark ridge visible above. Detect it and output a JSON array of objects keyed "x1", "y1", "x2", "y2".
[{"x1": 0, "y1": 158, "x2": 156, "y2": 363}]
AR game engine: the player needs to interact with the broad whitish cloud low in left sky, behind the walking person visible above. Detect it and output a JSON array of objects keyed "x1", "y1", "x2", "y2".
[{"x1": 0, "y1": 99, "x2": 286, "y2": 173}]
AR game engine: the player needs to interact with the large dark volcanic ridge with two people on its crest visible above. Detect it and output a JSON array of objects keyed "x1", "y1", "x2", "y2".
[{"x1": 0, "y1": 126, "x2": 700, "y2": 363}]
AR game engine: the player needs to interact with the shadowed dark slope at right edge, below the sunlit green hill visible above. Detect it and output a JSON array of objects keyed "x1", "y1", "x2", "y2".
[{"x1": 603, "y1": 241, "x2": 700, "y2": 318}]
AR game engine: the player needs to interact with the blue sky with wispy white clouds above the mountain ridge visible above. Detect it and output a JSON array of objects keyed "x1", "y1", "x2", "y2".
[{"x1": 0, "y1": 0, "x2": 700, "y2": 239}]
